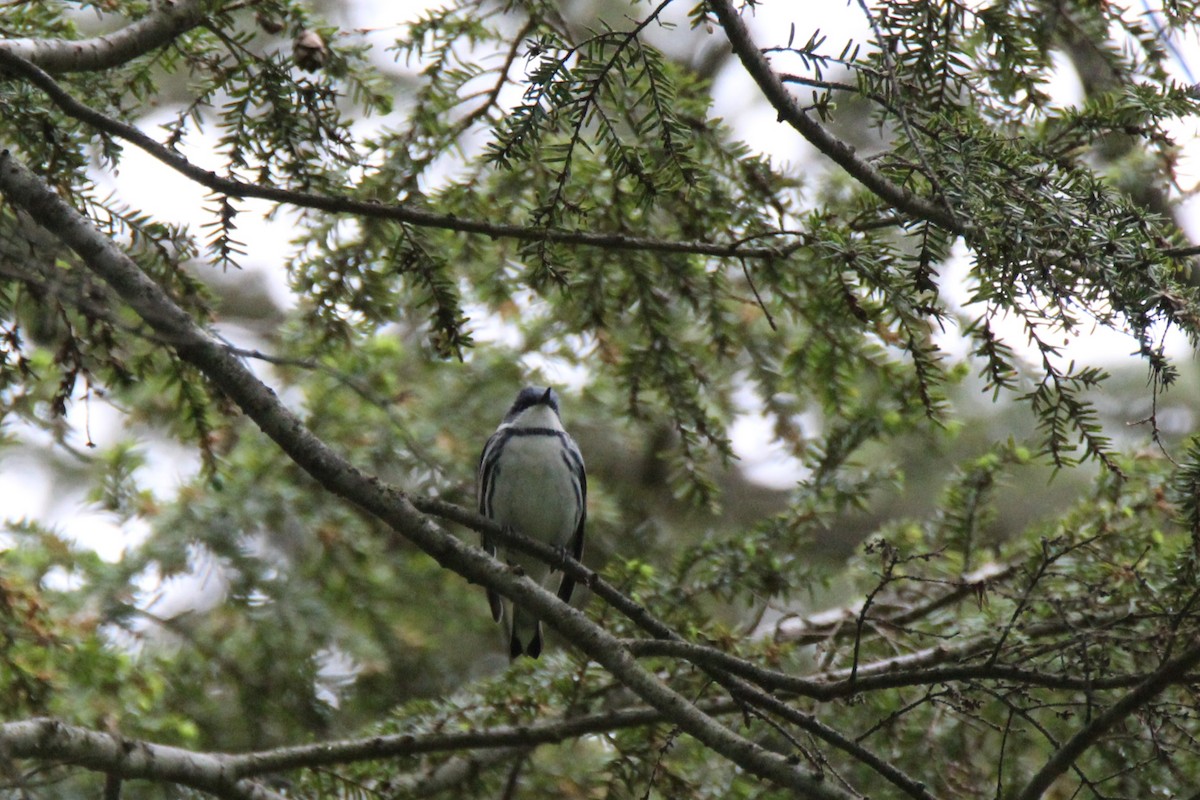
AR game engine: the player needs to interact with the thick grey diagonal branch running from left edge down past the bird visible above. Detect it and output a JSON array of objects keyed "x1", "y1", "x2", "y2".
[{"x1": 0, "y1": 151, "x2": 845, "y2": 800}]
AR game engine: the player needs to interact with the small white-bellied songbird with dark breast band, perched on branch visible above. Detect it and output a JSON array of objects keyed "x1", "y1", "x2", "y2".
[{"x1": 475, "y1": 386, "x2": 588, "y2": 658}]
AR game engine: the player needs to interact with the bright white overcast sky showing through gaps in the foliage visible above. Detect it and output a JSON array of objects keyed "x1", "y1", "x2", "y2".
[{"x1": 0, "y1": 0, "x2": 1200, "y2": 575}]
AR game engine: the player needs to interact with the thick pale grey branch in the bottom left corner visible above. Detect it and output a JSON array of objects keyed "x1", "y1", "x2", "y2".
[{"x1": 0, "y1": 720, "x2": 283, "y2": 800}]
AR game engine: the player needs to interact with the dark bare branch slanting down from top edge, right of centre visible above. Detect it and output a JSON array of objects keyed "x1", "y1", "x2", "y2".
[{"x1": 708, "y1": 0, "x2": 966, "y2": 234}]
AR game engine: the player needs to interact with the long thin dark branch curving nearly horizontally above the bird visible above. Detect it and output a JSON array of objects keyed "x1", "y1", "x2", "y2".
[{"x1": 0, "y1": 48, "x2": 798, "y2": 259}]
